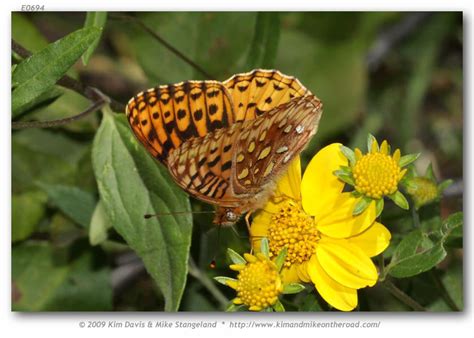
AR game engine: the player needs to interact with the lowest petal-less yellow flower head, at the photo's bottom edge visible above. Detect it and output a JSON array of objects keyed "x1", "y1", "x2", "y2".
[{"x1": 215, "y1": 240, "x2": 304, "y2": 312}]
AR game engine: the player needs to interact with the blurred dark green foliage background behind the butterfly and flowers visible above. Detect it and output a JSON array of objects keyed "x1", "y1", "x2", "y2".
[{"x1": 12, "y1": 12, "x2": 463, "y2": 311}]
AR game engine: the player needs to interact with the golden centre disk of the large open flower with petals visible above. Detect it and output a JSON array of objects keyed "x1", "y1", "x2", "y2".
[{"x1": 268, "y1": 201, "x2": 319, "y2": 266}]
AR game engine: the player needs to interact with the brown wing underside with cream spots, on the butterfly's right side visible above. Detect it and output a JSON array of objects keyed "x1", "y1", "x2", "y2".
[{"x1": 232, "y1": 95, "x2": 322, "y2": 195}]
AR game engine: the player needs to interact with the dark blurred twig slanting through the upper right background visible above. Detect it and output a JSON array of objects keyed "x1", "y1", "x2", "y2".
[{"x1": 366, "y1": 12, "x2": 431, "y2": 71}]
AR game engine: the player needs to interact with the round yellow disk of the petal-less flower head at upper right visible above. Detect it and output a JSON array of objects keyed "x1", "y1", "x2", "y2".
[{"x1": 353, "y1": 153, "x2": 400, "y2": 199}]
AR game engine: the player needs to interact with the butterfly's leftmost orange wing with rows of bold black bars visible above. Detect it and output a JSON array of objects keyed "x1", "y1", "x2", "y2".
[{"x1": 126, "y1": 81, "x2": 234, "y2": 164}]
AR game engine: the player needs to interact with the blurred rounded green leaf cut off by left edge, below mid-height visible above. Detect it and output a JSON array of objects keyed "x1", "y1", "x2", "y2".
[{"x1": 12, "y1": 191, "x2": 47, "y2": 242}]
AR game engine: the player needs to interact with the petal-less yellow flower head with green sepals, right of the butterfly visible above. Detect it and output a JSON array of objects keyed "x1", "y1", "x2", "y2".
[{"x1": 334, "y1": 134, "x2": 419, "y2": 216}]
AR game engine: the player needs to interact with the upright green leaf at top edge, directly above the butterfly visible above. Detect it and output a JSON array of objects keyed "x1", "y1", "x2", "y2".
[{"x1": 247, "y1": 12, "x2": 280, "y2": 69}]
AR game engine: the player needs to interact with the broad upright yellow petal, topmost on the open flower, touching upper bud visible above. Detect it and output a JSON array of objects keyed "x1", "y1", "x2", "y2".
[{"x1": 301, "y1": 143, "x2": 347, "y2": 216}]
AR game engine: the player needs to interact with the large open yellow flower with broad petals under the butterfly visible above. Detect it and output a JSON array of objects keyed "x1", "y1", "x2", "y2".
[{"x1": 250, "y1": 144, "x2": 390, "y2": 311}]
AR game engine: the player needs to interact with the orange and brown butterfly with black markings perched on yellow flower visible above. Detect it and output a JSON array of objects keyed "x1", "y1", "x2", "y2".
[{"x1": 126, "y1": 69, "x2": 322, "y2": 225}]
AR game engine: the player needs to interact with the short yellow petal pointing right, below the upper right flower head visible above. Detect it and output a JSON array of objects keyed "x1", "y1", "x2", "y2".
[{"x1": 347, "y1": 222, "x2": 392, "y2": 257}]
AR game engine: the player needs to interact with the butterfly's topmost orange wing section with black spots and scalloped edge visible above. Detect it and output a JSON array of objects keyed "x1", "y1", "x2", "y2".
[{"x1": 223, "y1": 69, "x2": 311, "y2": 121}]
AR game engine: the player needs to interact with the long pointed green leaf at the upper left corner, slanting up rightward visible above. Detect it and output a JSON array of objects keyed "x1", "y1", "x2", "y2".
[{"x1": 12, "y1": 27, "x2": 101, "y2": 117}]
